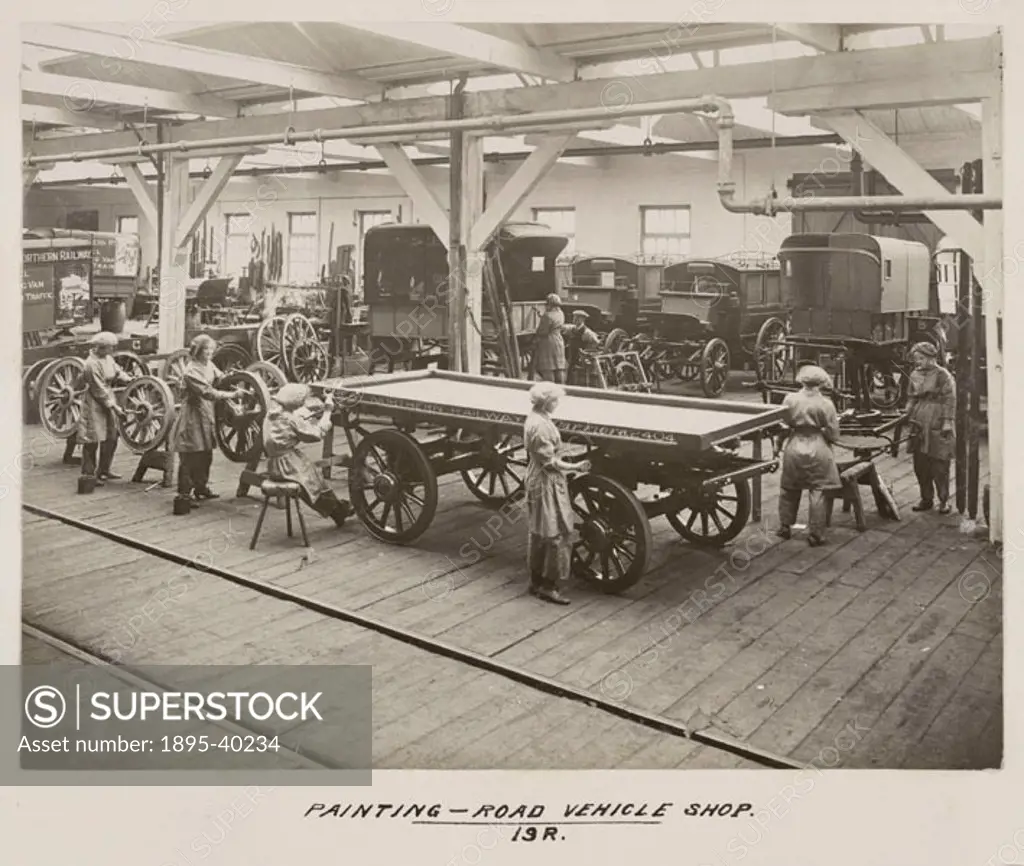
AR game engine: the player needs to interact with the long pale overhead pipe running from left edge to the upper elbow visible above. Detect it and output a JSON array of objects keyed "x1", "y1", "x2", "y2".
[{"x1": 24, "y1": 96, "x2": 732, "y2": 166}]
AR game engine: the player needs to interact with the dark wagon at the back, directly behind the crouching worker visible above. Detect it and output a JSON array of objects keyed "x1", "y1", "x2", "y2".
[{"x1": 560, "y1": 257, "x2": 640, "y2": 352}]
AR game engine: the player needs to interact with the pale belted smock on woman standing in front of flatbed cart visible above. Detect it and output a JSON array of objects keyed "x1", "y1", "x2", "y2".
[{"x1": 523, "y1": 412, "x2": 573, "y2": 538}]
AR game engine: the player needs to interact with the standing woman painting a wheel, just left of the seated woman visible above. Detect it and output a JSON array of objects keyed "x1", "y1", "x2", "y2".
[{"x1": 171, "y1": 334, "x2": 234, "y2": 514}]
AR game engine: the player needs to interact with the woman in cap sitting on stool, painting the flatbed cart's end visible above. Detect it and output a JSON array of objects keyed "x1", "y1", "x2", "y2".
[{"x1": 263, "y1": 383, "x2": 352, "y2": 526}]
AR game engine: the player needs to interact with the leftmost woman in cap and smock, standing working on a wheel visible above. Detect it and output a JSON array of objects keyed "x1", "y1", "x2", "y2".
[{"x1": 76, "y1": 331, "x2": 131, "y2": 486}]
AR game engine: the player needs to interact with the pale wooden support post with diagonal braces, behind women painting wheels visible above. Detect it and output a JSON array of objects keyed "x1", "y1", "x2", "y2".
[{"x1": 158, "y1": 157, "x2": 191, "y2": 354}]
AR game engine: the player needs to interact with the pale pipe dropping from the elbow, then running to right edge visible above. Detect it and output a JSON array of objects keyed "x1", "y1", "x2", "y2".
[{"x1": 718, "y1": 111, "x2": 1002, "y2": 216}]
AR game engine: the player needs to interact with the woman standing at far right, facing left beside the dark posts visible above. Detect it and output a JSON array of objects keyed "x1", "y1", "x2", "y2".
[{"x1": 907, "y1": 343, "x2": 956, "y2": 514}]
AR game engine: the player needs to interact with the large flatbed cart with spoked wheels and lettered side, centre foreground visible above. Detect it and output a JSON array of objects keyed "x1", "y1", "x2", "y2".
[{"x1": 312, "y1": 370, "x2": 782, "y2": 594}]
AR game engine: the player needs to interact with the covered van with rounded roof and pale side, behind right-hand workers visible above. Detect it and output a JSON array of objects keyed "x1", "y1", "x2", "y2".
[{"x1": 758, "y1": 233, "x2": 944, "y2": 412}]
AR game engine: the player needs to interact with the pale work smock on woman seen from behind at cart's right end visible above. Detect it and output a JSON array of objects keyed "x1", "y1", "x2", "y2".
[{"x1": 779, "y1": 391, "x2": 841, "y2": 490}]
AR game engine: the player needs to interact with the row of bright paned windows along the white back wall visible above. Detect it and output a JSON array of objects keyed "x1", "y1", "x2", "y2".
[{"x1": 108, "y1": 206, "x2": 690, "y2": 285}]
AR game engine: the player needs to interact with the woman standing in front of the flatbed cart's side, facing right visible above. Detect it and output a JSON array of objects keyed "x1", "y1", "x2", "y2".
[{"x1": 523, "y1": 382, "x2": 590, "y2": 605}]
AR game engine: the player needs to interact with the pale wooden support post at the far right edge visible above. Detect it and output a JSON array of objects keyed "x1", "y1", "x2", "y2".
[{"x1": 981, "y1": 91, "x2": 1005, "y2": 544}]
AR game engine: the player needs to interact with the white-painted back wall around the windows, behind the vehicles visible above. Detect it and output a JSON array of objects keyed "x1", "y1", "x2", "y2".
[{"x1": 25, "y1": 137, "x2": 980, "y2": 280}]
